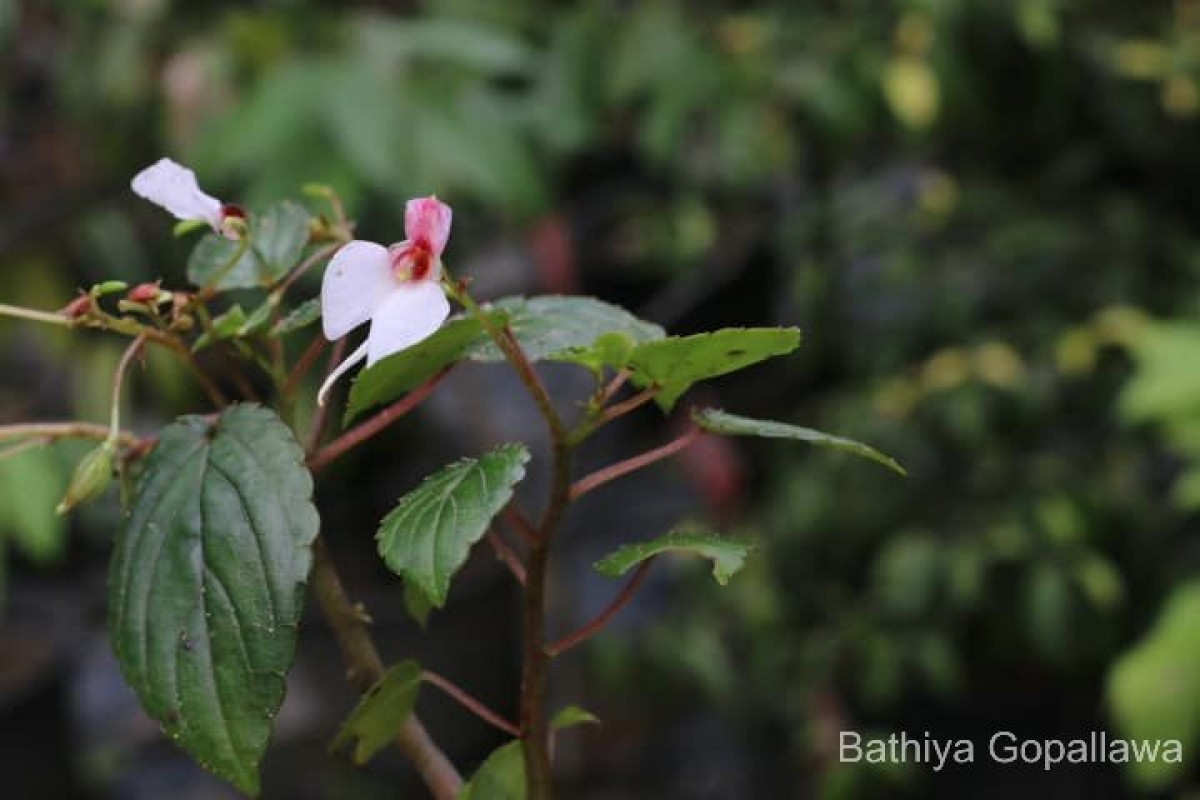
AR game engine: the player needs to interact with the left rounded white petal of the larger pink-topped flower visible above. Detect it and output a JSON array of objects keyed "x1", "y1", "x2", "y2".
[{"x1": 320, "y1": 240, "x2": 398, "y2": 341}]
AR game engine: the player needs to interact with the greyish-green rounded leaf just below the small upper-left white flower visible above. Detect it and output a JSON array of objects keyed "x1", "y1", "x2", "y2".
[{"x1": 187, "y1": 201, "x2": 308, "y2": 289}]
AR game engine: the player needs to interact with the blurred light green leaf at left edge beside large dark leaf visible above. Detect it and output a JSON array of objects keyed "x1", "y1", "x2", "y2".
[{"x1": 0, "y1": 447, "x2": 70, "y2": 564}]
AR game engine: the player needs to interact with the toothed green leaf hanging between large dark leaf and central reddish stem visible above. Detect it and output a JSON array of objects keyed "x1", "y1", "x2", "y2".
[{"x1": 376, "y1": 444, "x2": 529, "y2": 608}]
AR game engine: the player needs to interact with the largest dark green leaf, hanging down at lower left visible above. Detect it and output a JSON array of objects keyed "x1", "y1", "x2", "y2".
[{"x1": 108, "y1": 405, "x2": 319, "y2": 794}]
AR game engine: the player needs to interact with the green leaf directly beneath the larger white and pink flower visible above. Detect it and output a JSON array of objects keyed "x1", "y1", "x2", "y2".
[{"x1": 346, "y1": 313, "x2": 505, "y2": 421}]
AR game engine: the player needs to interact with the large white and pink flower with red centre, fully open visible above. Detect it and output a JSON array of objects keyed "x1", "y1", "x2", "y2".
[{"x1": 317, "y1": 197, "x2": 452, "y2": 405}]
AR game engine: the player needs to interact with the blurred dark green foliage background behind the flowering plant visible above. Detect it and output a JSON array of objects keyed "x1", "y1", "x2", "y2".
[{"x1": 7, "y1": 0, "x2": 1200, "y2": 800}]
